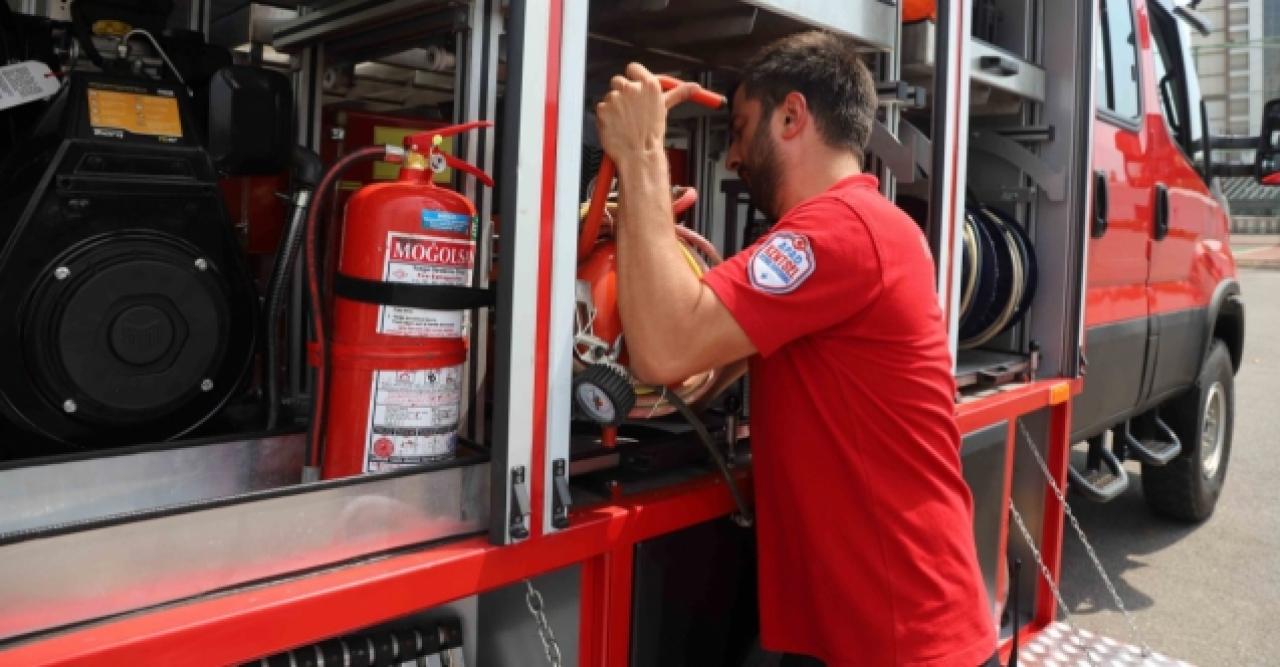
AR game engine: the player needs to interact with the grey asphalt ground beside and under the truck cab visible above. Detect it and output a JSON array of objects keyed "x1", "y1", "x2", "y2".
[{"x1": 1062, "y1": 269, "x2": 1280, "y2": 667}]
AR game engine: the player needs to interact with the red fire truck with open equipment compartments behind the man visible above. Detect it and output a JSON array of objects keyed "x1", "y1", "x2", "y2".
[{"x1": 0, "y1": 0, "x2": 1280, "y2": 667}]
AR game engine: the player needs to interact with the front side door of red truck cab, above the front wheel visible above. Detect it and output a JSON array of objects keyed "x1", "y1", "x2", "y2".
[{"x1": 1142, "y1": 1, "x2": 1226, "y2": 406}]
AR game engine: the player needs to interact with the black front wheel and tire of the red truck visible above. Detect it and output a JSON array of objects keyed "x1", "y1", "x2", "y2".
[{"x1": 1142, "y1": 341, "x2": 1235, "y2": 522}]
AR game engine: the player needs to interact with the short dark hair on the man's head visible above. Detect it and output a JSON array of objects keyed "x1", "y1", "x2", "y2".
[{"x1": 742, "y1": 31, "x2": 877, "y2": 161}]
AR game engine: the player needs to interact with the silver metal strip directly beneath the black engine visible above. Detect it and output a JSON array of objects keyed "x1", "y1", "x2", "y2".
[{"x1": 0, "y1": 434, "x2": 306, "y2": 535}]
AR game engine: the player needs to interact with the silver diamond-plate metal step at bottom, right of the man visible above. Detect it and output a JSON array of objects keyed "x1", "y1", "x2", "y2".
[{"x1": 1018, "y1": 622, "x2": 1194, "y2": 667}]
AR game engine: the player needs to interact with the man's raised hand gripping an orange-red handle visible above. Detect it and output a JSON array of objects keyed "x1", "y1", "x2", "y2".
[{"x1": 595, "y1": 63, "x2": 701, "y2": 164}]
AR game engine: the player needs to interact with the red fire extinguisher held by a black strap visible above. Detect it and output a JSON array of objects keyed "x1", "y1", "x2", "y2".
[{"x1": 308, "y1": 122, "x2": 493, "y2": 479}]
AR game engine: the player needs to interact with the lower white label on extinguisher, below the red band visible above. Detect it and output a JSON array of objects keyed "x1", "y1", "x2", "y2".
[{"x1": 365, "y1": 365, "x2": 462, "y2": 472}]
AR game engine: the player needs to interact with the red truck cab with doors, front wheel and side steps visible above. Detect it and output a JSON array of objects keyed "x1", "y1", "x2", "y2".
[{"x1": 1071, "y1": 0, "x2": 1244, "y2": 521}]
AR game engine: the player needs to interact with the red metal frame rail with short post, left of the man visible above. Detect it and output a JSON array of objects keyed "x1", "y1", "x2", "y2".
[{"x1": 0, "y1": 476, "x2": 733, "y2": 664}]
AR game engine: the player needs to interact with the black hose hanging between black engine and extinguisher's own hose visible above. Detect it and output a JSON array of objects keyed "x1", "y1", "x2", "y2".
[{"x1": 264, "y1": 147, "x2": 324, "y2": 429}]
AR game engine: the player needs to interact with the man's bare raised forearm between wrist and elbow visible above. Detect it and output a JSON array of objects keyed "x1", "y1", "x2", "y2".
[{"x1": 617, "y1": 150, "x2": 701, "y2": 379}]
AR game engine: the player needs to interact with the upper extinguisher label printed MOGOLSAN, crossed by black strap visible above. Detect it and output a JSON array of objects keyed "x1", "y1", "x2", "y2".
[{"x1": 378, "y1": 232, "x2": 476, "y2": 338}]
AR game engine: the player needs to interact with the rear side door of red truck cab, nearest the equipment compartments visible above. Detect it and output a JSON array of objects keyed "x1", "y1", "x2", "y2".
[{"x1": 1071, "y1": 0, "x2": 1152, "y2": 440}]
